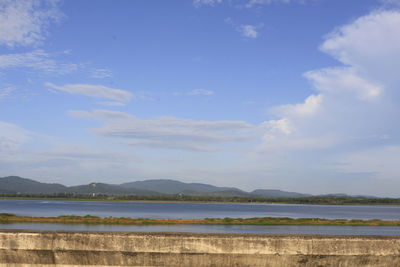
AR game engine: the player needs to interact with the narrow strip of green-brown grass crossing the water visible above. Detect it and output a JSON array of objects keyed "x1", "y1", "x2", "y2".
[{"x1": 0, "y1": 213, "x2": 400, "y2": 226}]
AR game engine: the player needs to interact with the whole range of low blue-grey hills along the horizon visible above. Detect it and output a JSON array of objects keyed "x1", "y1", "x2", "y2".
[{"x1": 0, "y1": 176, "x2": 362, "y2": 198}]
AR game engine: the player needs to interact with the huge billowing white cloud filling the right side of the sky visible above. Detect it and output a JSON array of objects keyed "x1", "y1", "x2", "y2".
[{"x1": 262, "y1": 11, "x2": 400, "y2": 184}]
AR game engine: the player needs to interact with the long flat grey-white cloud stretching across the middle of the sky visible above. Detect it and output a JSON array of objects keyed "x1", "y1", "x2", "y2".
[{"x1": 70, "y1": 110, "x2": 254, "y2": 151}]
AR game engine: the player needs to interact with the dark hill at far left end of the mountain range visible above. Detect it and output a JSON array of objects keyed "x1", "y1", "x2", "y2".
[{"x1": 0, "y1": 176, "x2": 69, "y2": 194}]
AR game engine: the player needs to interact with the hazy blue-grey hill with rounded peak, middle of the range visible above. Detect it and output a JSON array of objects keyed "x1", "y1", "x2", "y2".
[{"x1": 121, "y1": 179, "x2": 241, "y2": 194}]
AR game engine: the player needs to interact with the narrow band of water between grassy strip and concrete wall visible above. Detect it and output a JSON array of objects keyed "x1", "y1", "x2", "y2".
[{"x1": 0, "y1": 223, "x2": 400, "y2": 236}]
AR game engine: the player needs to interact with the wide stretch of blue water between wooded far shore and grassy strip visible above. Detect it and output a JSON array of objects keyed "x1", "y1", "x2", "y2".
[{"x1": 0, "y1": 200, "x2": 400, "y2": 220}]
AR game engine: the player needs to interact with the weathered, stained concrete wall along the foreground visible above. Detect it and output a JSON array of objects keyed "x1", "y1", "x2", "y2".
[{"x1": 0, "y1": 230, "x2": 400, "y2": 267}]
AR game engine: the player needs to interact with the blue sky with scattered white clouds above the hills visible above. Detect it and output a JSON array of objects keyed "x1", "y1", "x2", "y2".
[{"x1": 0, "y1": 0, "x2": 400, "y2": 197}]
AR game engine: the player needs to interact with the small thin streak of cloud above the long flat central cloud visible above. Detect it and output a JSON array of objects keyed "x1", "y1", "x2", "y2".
[{"x1": 45, "y1": 82, "x2": 133, "y2": 102}]
